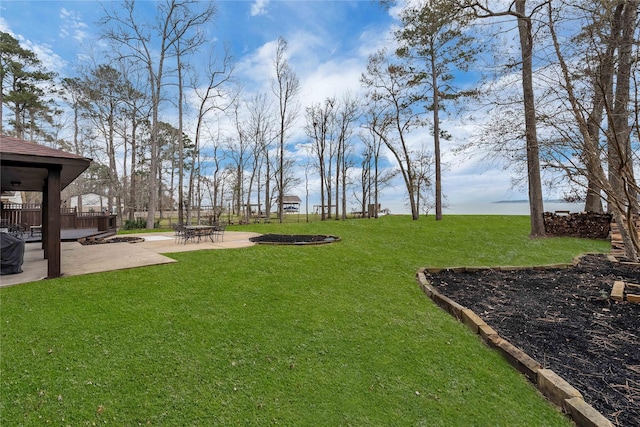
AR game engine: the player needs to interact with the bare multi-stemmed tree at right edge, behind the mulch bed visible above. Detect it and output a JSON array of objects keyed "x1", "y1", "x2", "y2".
[{"x1": 548, "y1": 1, "x2": 640, "y2": 261}]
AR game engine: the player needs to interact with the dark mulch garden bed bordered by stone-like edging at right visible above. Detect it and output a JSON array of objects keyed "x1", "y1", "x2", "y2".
[{"x1": 429, "y1": 255, "x2": 640, "y2": 426}]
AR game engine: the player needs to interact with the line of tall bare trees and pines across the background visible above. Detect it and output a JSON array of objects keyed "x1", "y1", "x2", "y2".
[{"x1": 0, "y1": 0, "x2": 640, "y2": 259}]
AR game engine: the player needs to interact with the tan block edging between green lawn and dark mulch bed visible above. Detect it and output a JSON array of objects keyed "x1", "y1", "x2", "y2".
[{"x1": 416, "y1": 257, "x2": 613, "y2": 427}]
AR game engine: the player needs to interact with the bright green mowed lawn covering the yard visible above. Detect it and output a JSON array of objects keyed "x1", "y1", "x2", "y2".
[{"x1": 0, "y1": 216, "x2": 608, "y2": 427}]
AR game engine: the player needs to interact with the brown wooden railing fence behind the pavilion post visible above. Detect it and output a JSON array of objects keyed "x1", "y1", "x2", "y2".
[{"x1": 0, "y1": 203, "x2": 117, "y2": 231}]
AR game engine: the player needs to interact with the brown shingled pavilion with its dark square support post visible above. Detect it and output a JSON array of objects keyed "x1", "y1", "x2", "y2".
[{"x1": 0, "y1": 135, "x2": 91, "y2": 279}]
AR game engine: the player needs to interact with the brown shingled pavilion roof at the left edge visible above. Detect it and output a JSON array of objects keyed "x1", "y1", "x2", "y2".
[{"x1": 0, "y1": 135, "x2": 91, "y2": 191}]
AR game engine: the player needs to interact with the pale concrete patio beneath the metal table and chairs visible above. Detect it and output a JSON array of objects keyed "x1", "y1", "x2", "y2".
[{"x1": 0, "y1": 231, "x2": 259, "y2": 287}]
